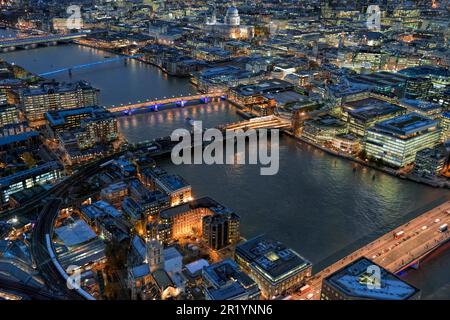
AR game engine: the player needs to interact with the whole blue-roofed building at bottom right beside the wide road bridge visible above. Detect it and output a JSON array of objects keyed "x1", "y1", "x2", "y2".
[{"x1": 321, "y1": 257, "x2": 420, "y2": 300}]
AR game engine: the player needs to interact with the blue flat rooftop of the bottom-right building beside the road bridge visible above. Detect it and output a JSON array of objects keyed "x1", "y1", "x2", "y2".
[{"x1": 324, "y1": 257, "x2": 419, "y2": 300}]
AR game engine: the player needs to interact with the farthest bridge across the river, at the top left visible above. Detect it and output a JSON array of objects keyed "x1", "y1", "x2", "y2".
[{"x1": 0, "y1": 32, "x2": 88, "y2": 51}]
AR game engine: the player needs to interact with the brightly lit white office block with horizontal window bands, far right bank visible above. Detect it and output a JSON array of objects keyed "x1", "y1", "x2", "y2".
[{"x1": 365, "y1": 113, "x2": 442, "y2": 168}]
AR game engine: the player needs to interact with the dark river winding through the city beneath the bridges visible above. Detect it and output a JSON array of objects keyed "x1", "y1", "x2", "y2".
[{"x1": 0, "y1": 45, "x2": 450, "y2": 299}]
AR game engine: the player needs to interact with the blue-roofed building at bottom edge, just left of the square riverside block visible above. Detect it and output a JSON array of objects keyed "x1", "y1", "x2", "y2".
[{"x1": 202, "y1": 259, "x2": 261, "y2": 300}]
